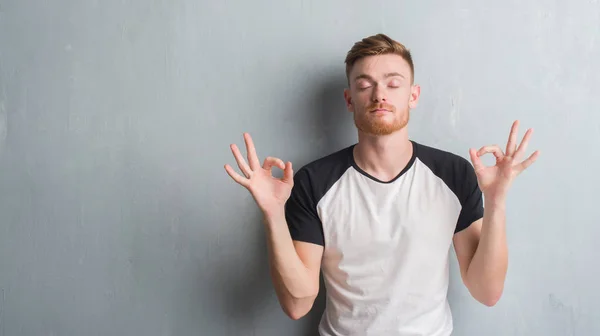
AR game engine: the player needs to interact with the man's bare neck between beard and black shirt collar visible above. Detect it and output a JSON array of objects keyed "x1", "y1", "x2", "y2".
[{"x1": 354, "y1": 127, "x2": 413, "y2": 181}]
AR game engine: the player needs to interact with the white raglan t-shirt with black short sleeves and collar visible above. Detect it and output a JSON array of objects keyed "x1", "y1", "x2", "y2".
[{"x1": 286, "y1": 141, "x2": 483, "y2": 336}]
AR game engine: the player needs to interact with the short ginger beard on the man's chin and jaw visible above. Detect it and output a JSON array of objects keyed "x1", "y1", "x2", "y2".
[{"x1": 354, "y1": 103, "x2": 410, "y2": 136}]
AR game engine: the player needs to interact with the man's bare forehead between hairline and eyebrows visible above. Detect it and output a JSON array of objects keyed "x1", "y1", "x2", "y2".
[{"x1": 350, "y1": 54, "x2": 411, "y2": 80}]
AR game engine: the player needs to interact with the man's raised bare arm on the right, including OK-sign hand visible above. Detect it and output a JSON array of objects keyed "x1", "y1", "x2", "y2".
[{"x1": 454, "y1": 121, "x2": 539, "y2": 306}]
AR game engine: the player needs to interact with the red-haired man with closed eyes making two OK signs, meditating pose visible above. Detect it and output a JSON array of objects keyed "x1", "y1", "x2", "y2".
[{"x1": 225, "y1": 34, "x2": 539, "y2": 336}]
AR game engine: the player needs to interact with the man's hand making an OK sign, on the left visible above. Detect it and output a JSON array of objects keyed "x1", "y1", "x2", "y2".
[{"x1": 225, "y1": 133, "x2": 294, "y2": 215}]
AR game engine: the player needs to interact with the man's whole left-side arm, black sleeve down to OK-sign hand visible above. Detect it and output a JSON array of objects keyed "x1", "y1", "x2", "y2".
[{"x1": 225, "y1": 133, "x2": 323, "y2": 319}]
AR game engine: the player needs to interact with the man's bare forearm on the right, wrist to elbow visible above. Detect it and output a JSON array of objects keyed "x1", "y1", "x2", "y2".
[{"x1": 467, "y1": 200, "x2": 508, "y2": 306}]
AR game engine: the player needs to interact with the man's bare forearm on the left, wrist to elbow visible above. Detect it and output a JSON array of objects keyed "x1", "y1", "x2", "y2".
[{"x1": 265, "y1": 211, "x2": 319, "y2": 318}]
